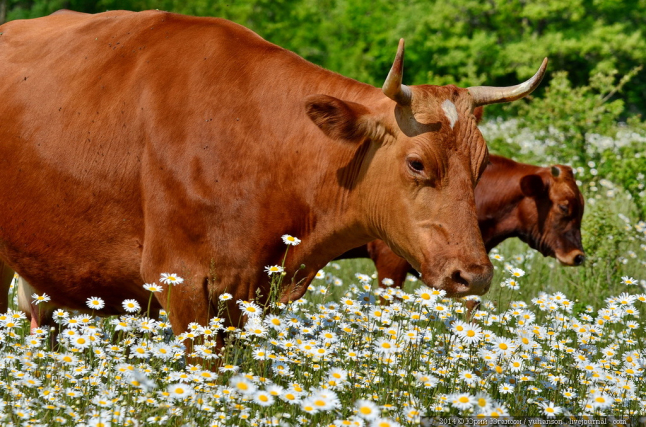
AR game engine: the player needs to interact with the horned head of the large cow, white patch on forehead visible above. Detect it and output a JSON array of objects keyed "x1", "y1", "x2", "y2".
[{"x1": 306, "y1": 40, "x2": 546, "y2": 296}]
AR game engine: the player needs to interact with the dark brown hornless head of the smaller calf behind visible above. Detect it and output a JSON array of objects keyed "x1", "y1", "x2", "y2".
[{"x1": 519, "y1": 165, "x2": 585, "y2": 265}]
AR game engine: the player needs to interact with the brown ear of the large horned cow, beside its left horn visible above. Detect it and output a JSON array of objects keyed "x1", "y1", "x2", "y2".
[{"x1": 305, "y1": 95, "x2": 385, "y2": 141}]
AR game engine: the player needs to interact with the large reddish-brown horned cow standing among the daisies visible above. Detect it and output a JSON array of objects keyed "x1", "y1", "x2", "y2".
[{"x1": 0, "y1": 11, "x2": 546, "y2": 340}]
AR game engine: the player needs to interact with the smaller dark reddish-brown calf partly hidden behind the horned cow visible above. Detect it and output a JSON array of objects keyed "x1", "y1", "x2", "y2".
[{"x1": 338, "y1": 155, "x2": 585, "y2": 287}]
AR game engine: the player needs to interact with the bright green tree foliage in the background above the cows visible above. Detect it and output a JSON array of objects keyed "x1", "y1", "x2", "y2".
[{"x1": 0, "y1": 0, "x2": 646, "y2": 113}]
